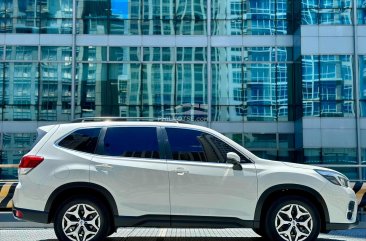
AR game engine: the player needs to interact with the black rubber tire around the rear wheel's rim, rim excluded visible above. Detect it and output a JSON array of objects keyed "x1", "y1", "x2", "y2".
[{"x1": 54, "y1": 197, "x2": 110, "y2": 241}]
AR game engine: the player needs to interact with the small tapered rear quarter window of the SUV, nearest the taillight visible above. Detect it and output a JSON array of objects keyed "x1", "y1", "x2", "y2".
[{"x1": 58, "y1": 128, "x2": 101, "y2": 153}]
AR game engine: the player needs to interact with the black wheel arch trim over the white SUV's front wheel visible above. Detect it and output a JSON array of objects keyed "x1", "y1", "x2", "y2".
[{"x1": 254, "y1": 184, "x2": 329, "y2": 230}]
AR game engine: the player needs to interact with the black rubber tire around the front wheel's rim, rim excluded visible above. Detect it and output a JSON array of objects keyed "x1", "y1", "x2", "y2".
[{"x1": 264, "y1": 196, "x2": 320, "y2": 241}]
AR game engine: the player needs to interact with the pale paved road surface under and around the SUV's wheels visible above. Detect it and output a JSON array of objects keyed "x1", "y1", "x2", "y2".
[{"x1": 0, "y1": 228, "x2": 366, "y2": 241}]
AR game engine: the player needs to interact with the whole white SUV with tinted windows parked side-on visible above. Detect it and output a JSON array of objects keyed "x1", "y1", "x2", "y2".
[{"x1": 13, "y1": 121, "x2": 357, "y2": 241}]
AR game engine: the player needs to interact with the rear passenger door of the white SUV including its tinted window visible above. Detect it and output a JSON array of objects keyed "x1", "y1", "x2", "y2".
[{"x1": 90, "y1": 126, "x2": 170, "y2": 222}]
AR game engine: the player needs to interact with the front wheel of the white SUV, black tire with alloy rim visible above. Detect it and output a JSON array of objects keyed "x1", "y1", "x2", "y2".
[{"x1": 264, "y1": 196, "x2": 320, "y2": 241}]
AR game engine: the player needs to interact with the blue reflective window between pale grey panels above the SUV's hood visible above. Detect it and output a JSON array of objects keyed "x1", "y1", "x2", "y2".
[{"x1": 302, "y1": 55, "x2": 355, "y2": 117}]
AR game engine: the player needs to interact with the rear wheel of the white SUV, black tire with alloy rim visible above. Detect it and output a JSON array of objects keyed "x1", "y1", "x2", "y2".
[{"x1": 54, "y1": 197, "x2": 110, "y2": 241}]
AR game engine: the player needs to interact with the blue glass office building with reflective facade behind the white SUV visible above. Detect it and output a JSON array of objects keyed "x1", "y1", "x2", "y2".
[{"x1": 0, "y1": 0, "x2": 366, "y2": 181}]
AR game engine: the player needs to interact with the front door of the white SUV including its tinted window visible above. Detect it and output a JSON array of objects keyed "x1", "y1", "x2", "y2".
[{"x1": 165, "y1": 128, "x2": 257, "y2": 225}]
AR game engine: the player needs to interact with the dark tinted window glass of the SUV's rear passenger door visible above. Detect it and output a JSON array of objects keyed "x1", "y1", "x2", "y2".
[{"x1": 103, "y1": 127, "x2": 160, "y2": 159}]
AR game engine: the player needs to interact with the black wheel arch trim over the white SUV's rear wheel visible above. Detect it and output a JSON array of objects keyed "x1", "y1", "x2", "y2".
[{"x1": 45, "y1": 182, "x2": 118, "y2": 222}]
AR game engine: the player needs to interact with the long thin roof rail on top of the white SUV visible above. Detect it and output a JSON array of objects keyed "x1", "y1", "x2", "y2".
[{"x1": 71, "y1": 116, "x2": 180, "y2": 123}]
